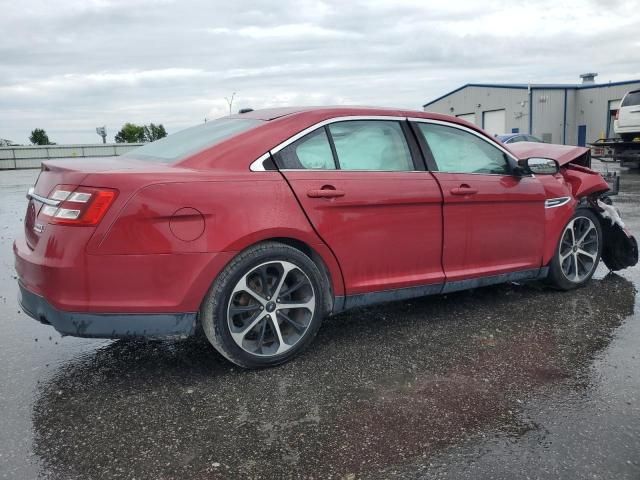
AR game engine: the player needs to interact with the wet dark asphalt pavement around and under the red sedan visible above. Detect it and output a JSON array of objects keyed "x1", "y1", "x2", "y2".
[{"x1": 0, "y1": 163, "x2": 640, "y2": 479}]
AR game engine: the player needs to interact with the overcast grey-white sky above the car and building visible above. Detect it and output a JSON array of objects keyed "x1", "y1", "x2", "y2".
[{"x1": 0, "y1": 0, "x2": 640, "y2": 143}]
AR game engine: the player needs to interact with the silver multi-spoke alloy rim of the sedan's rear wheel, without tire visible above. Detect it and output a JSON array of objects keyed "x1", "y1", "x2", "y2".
[{"x1": 227, "y1": 260, "x2": 316, "y2": 356}]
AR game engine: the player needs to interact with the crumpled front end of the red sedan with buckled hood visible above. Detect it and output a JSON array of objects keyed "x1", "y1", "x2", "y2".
[{"x1": 510, "y1": 142, "x2": 638, "y2": 271}]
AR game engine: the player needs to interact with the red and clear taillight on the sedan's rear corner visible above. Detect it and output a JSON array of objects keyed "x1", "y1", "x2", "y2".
[{"x1": 40, "y1": 185, "x2": 118, "y2": 225}]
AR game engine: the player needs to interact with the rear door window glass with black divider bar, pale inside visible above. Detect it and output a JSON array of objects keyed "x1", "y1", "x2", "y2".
[{"x1": 275, "y1": 120, "x2": 414, "y2": 171}]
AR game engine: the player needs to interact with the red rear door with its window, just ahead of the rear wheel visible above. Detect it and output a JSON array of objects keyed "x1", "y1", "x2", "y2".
[{"x1": 272, "y1": 117, "x2": 444, "y2": 295}]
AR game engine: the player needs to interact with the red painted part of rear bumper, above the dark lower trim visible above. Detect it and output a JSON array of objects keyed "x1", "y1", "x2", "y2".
[{"x1": 13, "y1": 233, "x2": 234, "y2": 315}]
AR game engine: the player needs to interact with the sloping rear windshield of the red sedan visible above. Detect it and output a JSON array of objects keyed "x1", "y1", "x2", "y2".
[{"x1": 123, "y1": 118, "x2": 264, "y2": 163}]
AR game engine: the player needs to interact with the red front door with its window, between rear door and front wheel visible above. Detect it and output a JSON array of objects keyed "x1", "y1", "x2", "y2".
[{"x1": 415, "y1": 121, "x2": 545, "y2": 282}]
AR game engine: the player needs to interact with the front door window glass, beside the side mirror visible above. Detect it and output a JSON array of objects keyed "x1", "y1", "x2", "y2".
[{"x1": 418, "y1": 123, "x2": 509, "y2": 175}]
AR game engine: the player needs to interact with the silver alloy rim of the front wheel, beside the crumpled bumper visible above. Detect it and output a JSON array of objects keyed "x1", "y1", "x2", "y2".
[{"x1": 559, "y1": 217, "x2": 599, "y2": 283}]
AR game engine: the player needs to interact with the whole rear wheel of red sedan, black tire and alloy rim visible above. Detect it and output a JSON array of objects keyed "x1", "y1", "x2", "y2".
[{"x1": 200, "y1": 242, "x2": 326, "y2": 368}]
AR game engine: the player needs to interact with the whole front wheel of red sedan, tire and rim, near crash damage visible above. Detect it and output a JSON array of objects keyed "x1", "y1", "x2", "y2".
[{"x1": 547, "y1": 208, "x2": 603, "y2": 290}]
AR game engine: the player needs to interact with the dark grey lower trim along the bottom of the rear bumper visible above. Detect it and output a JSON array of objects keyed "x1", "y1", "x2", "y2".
[{"x1": 19, "y1": 283, "x2": 197, "y2": 339}]
